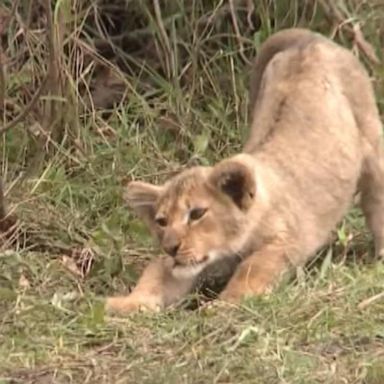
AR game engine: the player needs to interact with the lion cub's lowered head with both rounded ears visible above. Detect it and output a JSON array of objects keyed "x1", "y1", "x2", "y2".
[{"x1": 125, "y1": 159, "x2": 256, "y2": 271}]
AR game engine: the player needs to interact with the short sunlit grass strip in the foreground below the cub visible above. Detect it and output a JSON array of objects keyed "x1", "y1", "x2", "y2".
[{"x1": 0, "y1": 252, "x2": 384, "y2": 384}]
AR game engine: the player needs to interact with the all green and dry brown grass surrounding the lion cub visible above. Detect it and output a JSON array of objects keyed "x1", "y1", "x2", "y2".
[{"x1": 0, "y1": 0, "x2": 384, "y2": 384}]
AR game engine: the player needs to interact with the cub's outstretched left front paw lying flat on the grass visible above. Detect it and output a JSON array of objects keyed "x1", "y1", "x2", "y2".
[{"x1": 105, "y1": 295, "x2": 163, "y2": 315}]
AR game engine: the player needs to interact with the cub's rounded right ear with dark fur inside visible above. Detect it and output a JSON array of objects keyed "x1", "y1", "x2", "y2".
[{"x1": 209, "y1": 160, "x2": 256, "y2": 211}]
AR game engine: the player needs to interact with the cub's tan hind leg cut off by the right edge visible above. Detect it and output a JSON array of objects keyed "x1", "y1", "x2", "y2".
[{"x1": 359, "y1": 148, "x2": 384, "y2": 258}]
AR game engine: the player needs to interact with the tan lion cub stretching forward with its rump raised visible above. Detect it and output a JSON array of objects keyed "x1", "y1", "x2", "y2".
[{"x1": 106, "y1": 29, "x2": 384, "y2": 313}]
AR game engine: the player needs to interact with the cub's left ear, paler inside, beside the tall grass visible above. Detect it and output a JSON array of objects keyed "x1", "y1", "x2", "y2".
[{"x1": 123, "y1": 181, "x2": 163, "y2": 227}]
